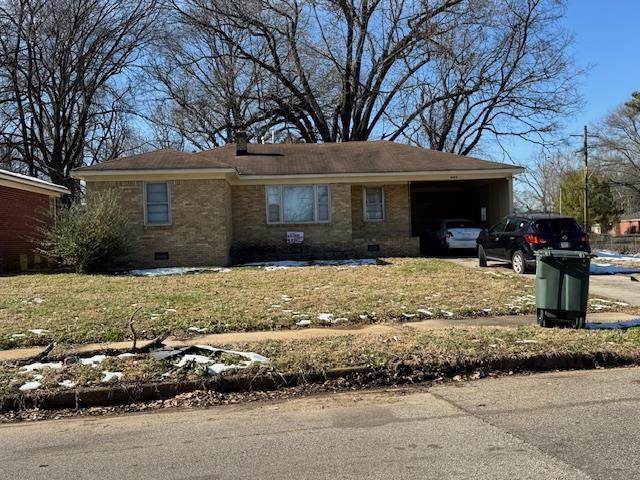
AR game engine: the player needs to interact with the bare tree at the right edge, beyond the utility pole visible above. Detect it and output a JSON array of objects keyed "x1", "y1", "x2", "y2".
[{"x1": 594, "y1": 92, "x2": 640, "y2": 213}]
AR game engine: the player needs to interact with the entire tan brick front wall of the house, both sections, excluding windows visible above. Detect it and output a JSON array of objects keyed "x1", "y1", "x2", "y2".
[{"x1": 87, "y1": 180, "x2": 419, "y2": 267}]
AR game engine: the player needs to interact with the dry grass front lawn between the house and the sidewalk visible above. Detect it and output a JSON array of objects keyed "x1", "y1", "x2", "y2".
[{"x1": 0, "y1": 258, "x2": 620, "y2": 349}]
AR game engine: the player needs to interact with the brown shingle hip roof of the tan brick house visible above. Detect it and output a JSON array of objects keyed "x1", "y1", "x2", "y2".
[{"x1": 77, "y1": 141, "x2": 517, "y2": 176}]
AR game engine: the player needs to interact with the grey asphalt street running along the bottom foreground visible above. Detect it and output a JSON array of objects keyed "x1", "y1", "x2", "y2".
[{"x1": 0, "y1": 368, "x2": 640, "y2": 480}]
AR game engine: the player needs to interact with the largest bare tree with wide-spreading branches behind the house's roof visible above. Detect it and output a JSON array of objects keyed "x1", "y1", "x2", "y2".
[{"x1": 166, "y1": 0, "x2": 577, "y2": 150}]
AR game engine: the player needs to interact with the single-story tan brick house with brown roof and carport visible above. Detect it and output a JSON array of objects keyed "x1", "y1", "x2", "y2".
[{"x1": 74, "y1": 137, "x2": 523, "y2": 267}]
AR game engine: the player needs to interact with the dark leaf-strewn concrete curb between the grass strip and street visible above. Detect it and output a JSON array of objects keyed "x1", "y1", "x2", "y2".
[{"x1": 0, "y1": 352, "x2": 640, "y2": 412}]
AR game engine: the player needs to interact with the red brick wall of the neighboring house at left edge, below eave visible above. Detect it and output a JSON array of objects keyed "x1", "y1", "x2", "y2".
[{"x1": 0, "y1": 186, "x2": 50, "y2": 271}]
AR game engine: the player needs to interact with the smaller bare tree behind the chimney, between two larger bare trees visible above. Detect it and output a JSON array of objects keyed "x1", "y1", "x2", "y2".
[{"x1": 146, "y1": 5, "x2": 268, "y2": 150}]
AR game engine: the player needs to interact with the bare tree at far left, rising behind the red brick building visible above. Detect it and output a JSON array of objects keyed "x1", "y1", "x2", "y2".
[{"x1": 0, "y1": 0, "x2": 159, "y2": 195}]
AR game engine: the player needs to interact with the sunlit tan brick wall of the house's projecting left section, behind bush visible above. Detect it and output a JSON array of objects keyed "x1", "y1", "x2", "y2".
[{"x1": 87, "y1": 180, "x2": 231, "y2": 267}]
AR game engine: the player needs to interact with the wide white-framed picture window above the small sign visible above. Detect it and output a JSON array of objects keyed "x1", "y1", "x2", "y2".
[{"x1": 267, "y1": 185, "x2": 330, "y2": 223}]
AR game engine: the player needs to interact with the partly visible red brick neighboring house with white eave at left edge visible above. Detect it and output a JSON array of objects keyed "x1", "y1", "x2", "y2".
[{"x1": 0, "y1": 170, "x2": 69, "y2": 272}]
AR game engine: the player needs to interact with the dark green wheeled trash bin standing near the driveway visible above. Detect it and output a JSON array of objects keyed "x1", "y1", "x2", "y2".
[{"x1": 536, "y1": 249, "x2": 592, "y2": 328}]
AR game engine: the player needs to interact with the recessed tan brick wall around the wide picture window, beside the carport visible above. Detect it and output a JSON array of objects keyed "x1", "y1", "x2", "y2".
[{"x1": 231, "y1": 184, "x2": 420, "y2": 262}]
